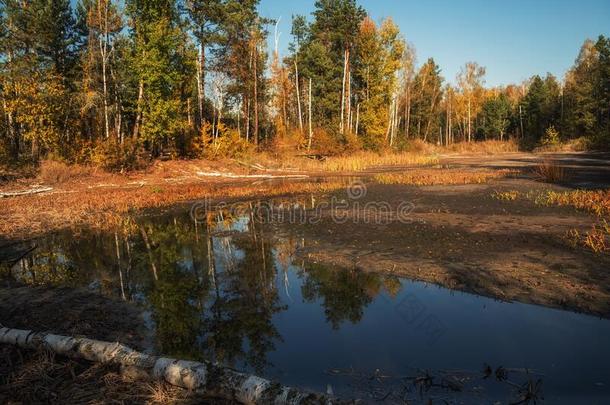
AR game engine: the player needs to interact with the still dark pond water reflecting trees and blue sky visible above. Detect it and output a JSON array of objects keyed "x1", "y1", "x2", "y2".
[{"x1": 4, "y1": 196, "x2": 610, "y2": 404}]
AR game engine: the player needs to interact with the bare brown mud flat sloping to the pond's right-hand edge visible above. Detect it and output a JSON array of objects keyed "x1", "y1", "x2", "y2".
[{"x1": 288, "y1": 179, "x2": 610, "y2": 317}]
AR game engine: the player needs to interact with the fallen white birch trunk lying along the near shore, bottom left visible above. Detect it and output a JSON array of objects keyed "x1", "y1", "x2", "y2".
[{"x1": 0, "y1": 325, "x2": 341, "y2": 405}]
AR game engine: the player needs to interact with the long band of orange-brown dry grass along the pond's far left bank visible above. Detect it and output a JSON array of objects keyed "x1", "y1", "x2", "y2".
[{"x1": 0, "y1": 179, "x2": 344, "y2": 238}]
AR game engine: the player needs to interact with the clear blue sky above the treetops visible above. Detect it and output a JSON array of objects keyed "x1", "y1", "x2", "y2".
[{"x1": 259, "y1": 0, "x2": 610, "y2": 86}]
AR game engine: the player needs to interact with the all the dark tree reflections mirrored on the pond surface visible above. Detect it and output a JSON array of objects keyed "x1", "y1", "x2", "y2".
[{"x1": 4, "y1": 197, "x2": 400, "y2": 372}]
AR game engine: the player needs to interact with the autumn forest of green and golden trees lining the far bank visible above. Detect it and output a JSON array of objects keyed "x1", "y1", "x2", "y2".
[{"x1": 0, "y1": 0, "x2": 610, "y2": 170}]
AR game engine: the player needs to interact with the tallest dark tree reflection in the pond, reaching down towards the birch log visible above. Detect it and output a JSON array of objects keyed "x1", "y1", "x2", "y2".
[{"x1": 205, "y1": 202, "x2": 286, "y2": 371}]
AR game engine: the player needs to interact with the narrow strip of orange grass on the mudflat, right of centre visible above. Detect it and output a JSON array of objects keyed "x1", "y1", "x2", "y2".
[{"x1": 375, "y1": 169, "x2": 517, "y2": 186}]
